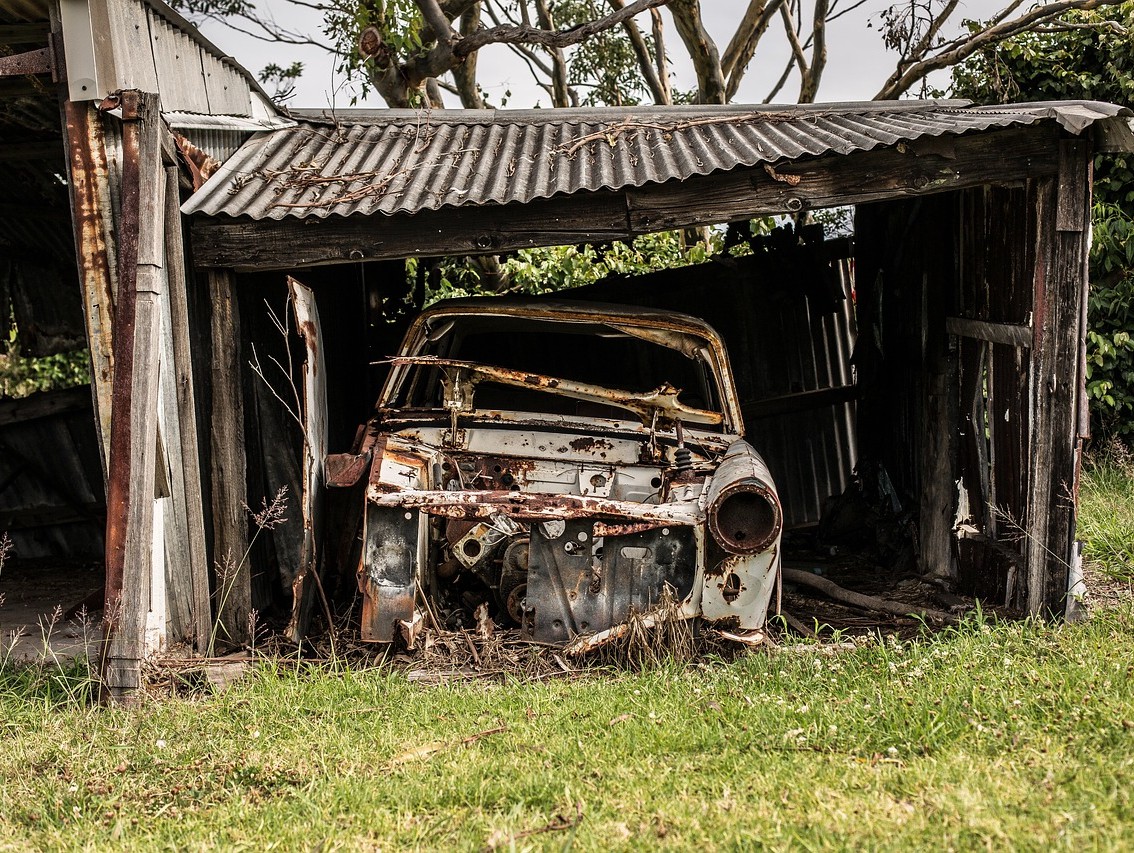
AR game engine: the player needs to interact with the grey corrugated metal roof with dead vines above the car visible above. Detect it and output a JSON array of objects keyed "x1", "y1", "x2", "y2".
[{"x1": 184, "y1": 101, "x2": 1134, "y2": 219}]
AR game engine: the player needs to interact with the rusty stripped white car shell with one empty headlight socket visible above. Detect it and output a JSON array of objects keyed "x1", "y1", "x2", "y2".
[{"x1": 325, "y1": 297, "x2": 782, "y2": 644}]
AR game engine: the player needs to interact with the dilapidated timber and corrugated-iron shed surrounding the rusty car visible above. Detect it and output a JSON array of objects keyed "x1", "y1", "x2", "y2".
[{"x1": 0, "y1": 0, "x2": 1134, "y2": 694}]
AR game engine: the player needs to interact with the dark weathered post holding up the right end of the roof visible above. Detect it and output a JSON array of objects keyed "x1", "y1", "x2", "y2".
[{"x1": 1021, "y1": 140, "x2": 1091, "y2": 617}]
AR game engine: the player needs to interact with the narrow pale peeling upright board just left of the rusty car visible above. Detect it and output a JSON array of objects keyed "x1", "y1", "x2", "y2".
[{"x1": 287, "y1": 276, "x2": 327, "y2": 643}]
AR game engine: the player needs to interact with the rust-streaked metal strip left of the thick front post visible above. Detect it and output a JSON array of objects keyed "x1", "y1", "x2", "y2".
[{"x1": 64, "y1": 101, "x2": 117, "y2": 474}]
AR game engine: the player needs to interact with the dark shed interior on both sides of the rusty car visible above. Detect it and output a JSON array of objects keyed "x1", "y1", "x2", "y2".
[{"x1": 218, "y1": 216, "x2": 959, "y2": 644}]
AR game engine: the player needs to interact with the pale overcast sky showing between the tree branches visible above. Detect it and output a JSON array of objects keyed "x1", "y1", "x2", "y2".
[{"x1": 192, "y1": 0, "x2": 1001, "y2": 109}]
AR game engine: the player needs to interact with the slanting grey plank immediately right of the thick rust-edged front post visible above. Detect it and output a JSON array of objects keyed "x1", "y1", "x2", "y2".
[{"x1": 166, "y1": 167, "x2": 212, "y2": 653}]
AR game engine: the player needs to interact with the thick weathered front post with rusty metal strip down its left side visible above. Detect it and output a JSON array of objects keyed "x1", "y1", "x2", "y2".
[{"x1": 102, "y1": 90, "x2": 166, "y2": 701}]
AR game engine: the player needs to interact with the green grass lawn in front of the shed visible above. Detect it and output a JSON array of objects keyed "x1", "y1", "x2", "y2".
[{"x1": 0, "y1": 460, "x2": 1134, "y2": 851}]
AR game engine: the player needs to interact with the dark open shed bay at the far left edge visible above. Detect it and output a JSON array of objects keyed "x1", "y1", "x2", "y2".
[{"x1": 0, "y1": 36, "x2": 105, "y2": 658}]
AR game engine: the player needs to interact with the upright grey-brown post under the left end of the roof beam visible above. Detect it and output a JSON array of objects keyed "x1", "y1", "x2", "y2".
[{"x1": 208, "y1": 270, "x2": 252, "y2": 645}]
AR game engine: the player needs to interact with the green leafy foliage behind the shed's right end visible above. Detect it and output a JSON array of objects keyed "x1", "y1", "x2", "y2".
[{"x1": 953, "y1": 1, "x2": 1134, "y2": 436}]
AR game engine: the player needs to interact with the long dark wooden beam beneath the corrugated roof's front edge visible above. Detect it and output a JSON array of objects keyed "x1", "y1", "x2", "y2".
[{"x1": 193, "y1": 126, "x2": 1058, "y2": 271}]
